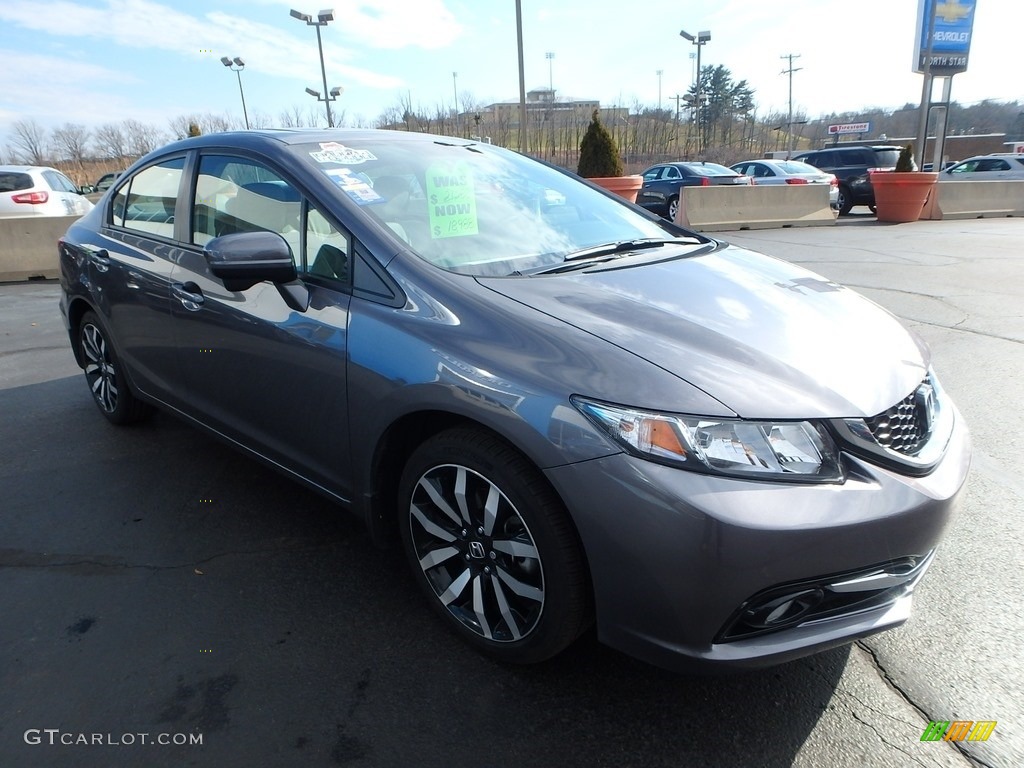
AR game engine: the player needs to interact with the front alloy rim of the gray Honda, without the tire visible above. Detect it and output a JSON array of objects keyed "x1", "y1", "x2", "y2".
[{"x1": 409, "y1": 464, "x2": 544, "y2": 642}]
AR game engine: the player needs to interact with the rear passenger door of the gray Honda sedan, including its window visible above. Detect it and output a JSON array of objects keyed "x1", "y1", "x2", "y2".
[{"x1": 89, "y1": 154, "x2": 191, "y2": 408}]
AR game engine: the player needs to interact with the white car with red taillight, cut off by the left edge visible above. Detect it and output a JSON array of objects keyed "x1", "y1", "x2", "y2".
[{"x1": 0, "y1": 165, "x2": 92, "y2": 218}]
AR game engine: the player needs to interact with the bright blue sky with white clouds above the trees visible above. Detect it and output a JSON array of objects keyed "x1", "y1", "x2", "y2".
[{"x1": 0, "y1": 0, "x2": 1024, "y2": 144}]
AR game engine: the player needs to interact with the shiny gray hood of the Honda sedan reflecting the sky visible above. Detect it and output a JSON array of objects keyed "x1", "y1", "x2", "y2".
[{"x1": 477, "y1": 246, "x2": 928, "y2": 419}]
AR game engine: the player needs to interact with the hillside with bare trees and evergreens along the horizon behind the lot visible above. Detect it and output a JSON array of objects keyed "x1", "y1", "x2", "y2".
[{"x1": 0, "y1": 66, "x2": 1024, "y2": 184}]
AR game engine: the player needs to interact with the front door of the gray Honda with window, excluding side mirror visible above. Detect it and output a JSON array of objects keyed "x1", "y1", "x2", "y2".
[{"x1": 171, "y1": 152, "x2": 352, "y2": 496}]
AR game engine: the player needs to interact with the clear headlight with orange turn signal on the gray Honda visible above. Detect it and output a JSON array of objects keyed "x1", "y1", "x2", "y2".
[{"x1": 571, "y1": 395, "x2": 844, "y2": 482}]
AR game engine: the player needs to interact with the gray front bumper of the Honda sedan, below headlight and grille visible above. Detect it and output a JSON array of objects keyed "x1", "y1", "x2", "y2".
[{"x1": 547, "y1": 414, "x2": 970, "y2": 671}]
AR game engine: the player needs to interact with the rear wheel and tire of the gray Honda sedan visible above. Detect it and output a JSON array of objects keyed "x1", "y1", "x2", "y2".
[{"x1": 78, "y1": 311, "x2": 152, "y2": 424}]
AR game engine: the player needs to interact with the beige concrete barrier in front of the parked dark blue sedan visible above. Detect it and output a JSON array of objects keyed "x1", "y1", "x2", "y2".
[{"x1": 676, "y1": 184, "x2": 837, "y2": 231}]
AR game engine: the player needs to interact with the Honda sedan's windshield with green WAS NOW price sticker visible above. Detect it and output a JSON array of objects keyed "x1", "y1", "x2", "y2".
[{"x1": 297, "y1": 136, "x2": 685, "y2": 275}]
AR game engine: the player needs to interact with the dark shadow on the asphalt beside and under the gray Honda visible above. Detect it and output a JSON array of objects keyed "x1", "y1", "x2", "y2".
[{"x1": 0, "y1": 377, "x2": 850, "y2": 767}]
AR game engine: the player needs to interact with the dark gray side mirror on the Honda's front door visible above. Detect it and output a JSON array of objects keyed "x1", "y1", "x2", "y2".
[{"x1": 203, "y1": 231, "x2": 297, "y2": 291}]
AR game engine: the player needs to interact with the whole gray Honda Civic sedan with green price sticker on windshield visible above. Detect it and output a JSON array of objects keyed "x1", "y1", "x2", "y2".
[{"x1": 59, "y1": 130, "x2": 970, "y2": 669}]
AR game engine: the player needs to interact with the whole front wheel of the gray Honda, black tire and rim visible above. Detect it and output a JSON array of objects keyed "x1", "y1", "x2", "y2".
[{"x1": 398, "y1": 428, "x2": 590, "y2": 664}]
